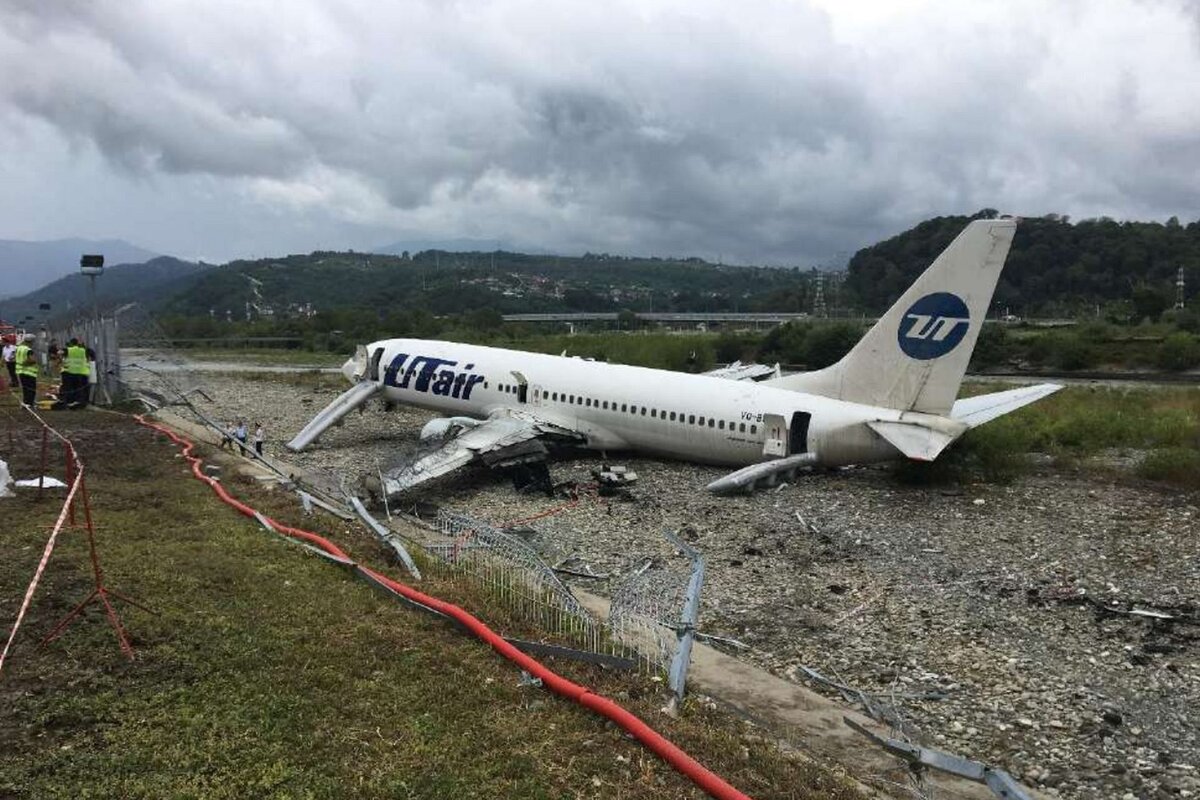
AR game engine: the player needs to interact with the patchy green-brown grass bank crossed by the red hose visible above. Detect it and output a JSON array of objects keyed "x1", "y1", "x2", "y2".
[{"x1": 0, "y1": 401, "x2": 857, "y2": 798}]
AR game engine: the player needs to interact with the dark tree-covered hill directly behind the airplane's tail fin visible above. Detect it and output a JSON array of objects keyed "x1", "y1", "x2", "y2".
[{"x1": 846, "y1": 209, "x2": 1200, "y2": 318}]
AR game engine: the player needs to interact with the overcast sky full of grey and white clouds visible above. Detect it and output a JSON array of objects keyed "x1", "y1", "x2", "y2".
[{"x1": 0, "y1": 0, "x2": 1200, "y2": 264}]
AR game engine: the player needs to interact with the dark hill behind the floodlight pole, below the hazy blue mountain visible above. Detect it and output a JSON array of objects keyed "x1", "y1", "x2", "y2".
[{"x1": 0, "y1": 255, "x2": 211, "y2": 321}]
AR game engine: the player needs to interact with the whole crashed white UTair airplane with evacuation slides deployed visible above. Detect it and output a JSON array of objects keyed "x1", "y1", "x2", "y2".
[{"x1": 288, "y1": 218, "x2": 1060, "y2": 495}]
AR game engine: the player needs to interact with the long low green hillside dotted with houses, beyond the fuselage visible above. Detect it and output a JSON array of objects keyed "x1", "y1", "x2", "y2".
[{"x1": 157, "y1": 251, "x2": 810, "y2": 318}]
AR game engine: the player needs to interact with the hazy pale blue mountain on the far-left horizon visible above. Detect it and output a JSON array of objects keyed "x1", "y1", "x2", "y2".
[{"x1": 0, "y1": 239, "x2": 160, "y2": 299}]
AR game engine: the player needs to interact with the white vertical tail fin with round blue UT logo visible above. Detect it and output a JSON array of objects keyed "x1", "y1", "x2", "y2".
[{"x1": 764, "y1": 219, "x2": 1016, "y2": 415}]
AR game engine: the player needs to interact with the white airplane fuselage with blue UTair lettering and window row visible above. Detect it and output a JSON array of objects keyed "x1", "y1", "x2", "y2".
[{"x1": 347, "y1": 339, "x2": 924, "y2": 467}]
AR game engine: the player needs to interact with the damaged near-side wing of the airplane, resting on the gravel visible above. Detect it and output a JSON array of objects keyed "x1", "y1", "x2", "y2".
[{"x1": 383, "y1": 409, "x2": 580, "y2": 497}]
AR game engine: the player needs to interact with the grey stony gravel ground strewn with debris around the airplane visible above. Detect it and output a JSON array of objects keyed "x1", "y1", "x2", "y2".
[{"x1": 150, "y1": 375, "x2": 1200, "y2": 798}]
